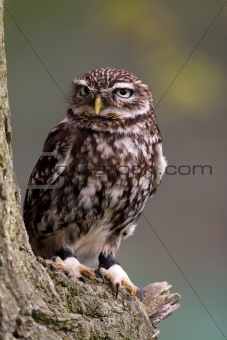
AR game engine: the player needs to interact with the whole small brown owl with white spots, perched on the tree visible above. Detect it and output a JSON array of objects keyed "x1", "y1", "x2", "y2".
[{"x1": 24, "y1": 68, "x2": 166, "y2": 294}]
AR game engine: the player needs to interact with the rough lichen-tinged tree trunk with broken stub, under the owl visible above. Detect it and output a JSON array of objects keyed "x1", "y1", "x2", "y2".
[{"x1": 0, "y1": 1, "x2": 180, "y2": 340}]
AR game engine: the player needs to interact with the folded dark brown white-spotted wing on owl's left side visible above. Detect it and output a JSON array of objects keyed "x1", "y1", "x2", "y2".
[{"x1": 24, "y1": 122, "x2": 70, "y2": 216}]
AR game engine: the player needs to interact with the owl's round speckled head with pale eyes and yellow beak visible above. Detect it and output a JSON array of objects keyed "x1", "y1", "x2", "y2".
[{"x1": 69, "y1": 67, "x2": 153, "y2": 119}]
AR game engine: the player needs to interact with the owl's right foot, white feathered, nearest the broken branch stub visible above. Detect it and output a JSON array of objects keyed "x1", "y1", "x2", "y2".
[{"x1": 100, "y1": 264, "x2": 140, "y2": 298}]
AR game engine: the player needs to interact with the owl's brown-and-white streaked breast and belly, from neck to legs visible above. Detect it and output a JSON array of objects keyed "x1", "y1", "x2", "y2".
[{"x1": 32, "y1": 125, "x2": 160, "y2": 260}]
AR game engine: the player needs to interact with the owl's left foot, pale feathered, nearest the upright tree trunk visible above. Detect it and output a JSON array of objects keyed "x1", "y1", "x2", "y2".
[{"x1": 53, "y1": 256, "x2": 96, "y2": 283}]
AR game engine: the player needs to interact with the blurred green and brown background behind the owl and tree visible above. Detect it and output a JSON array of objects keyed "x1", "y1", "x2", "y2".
[{"x1": 5, "y1": 0, "x2": 227, "y2": 340}]
